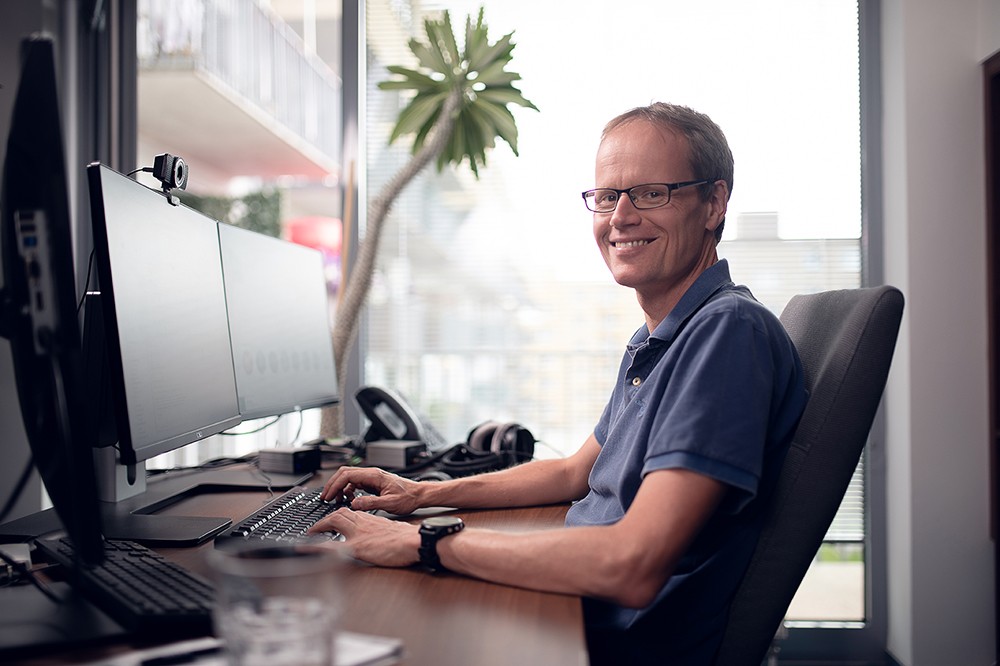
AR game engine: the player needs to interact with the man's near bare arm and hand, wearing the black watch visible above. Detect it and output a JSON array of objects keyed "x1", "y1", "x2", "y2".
[{"x1": 322, "y1": 470, "x2": 726, "y2": 608}]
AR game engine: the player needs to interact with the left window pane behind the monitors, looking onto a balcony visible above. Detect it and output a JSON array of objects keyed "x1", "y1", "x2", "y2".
[{"x1": 134, "y1": 0, "x2": 342, "y2": 467}]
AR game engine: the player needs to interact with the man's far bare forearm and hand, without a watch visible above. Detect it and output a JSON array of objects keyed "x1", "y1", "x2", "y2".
[{"x1": 322, "y1": 435, "x2": 601, "y2": 515}]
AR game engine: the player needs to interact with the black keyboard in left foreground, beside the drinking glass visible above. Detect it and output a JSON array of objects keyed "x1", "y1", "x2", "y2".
[{"x1": 35, "y1": 538, "x2": 215, "y2": 637}]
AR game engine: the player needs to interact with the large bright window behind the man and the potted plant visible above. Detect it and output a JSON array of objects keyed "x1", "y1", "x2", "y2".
[{"x1": 363, "y1": 0, "x2": 866, "y2": 644}]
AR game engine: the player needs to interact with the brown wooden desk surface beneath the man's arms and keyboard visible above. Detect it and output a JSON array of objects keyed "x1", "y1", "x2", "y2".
[{"x1": 13, "y1": 470, "x2": 587, "y2": 666}]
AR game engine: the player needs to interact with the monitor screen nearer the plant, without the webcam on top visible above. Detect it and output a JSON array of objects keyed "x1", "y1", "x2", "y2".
[{"x1": 219, "y1": 224, "x2": 338, "y2": 419}]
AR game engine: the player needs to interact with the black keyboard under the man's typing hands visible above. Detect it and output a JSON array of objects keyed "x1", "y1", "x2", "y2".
[{"x1": 215, "y1": 486, "x2": 358, "y2": 548}]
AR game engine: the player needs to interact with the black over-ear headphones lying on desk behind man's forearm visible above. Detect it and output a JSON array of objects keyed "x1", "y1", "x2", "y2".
[{"x1": 405, "y1": 421, "x2": 537, "y2": 481}]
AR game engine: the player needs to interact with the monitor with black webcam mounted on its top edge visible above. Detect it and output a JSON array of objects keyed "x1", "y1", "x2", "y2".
[{"x1": 87, "y1": 164, "x2": 241, "y2": 465}]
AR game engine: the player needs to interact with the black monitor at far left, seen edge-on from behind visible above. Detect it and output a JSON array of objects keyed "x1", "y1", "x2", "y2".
[{"x1": 0, "y1": 35, "x2": 103, "y2": 563}]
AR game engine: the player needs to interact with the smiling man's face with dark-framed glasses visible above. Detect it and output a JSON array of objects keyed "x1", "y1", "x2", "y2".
[{"x1": 594, "y1": 121, "x2": 727, "y2": 300}]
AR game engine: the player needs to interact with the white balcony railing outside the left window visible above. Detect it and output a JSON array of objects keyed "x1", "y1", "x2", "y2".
[{"x1": 137, "y1": 0, "x2": 341, "y2": 166}]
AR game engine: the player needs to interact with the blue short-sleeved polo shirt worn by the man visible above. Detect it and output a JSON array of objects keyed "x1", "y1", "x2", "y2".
[{"x1": 566, "y1": 260, "x2": 807, "y2": 665}]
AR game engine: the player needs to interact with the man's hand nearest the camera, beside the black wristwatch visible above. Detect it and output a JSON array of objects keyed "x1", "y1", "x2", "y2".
[{"x1": 309, "y1": 509, "x2": 420, "y2": 567}]
